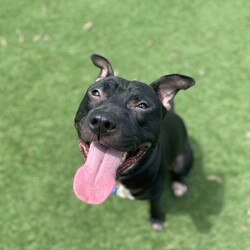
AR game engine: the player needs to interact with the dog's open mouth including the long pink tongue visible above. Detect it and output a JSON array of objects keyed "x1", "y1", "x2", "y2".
[{"x1": 74, "y1": 140, "x2": 151, "y2": 204}]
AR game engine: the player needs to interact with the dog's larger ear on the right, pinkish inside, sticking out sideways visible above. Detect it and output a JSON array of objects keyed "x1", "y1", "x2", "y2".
[{"x1": 151, "y1": 74, "x2": 195, "y2": 110}]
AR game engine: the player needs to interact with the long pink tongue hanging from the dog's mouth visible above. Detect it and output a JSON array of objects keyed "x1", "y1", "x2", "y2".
[{"x1": 73, "y1": 142, "x2": 122, "y2": 204}]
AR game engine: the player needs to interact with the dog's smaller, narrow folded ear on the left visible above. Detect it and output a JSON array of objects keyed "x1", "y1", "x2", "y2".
[{"x1": 91, "y1": 54, "x2": 114, "y2": 81}]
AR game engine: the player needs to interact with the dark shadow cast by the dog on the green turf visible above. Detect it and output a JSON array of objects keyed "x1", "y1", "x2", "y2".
[{"x1": 163, "y1": 139, "x2": 224, "y2": 232}]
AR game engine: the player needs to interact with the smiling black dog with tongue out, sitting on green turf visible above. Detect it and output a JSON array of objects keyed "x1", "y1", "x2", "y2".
[{"x1": 74, "y1": 55, "x2": 194, "y2": 230}]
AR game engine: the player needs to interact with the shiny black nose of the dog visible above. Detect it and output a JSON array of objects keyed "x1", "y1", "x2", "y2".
[{"x1": 89, "y1": 113, "x2": 116, "y2": 140}]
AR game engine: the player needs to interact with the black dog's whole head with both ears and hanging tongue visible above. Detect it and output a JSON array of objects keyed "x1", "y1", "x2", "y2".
[{"x1": 74, "y1": 55, "x2": 194, "y2": 204}]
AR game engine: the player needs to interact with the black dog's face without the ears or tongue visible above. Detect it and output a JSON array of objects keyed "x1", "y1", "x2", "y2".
[{"x1": 75, "y1": 76, "x2": 165, "y2": 169}]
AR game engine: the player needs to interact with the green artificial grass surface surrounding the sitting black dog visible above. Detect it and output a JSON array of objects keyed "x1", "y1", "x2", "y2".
[{"x1": 0, "y1": 0, "x2": 250, "y2": 250}]
